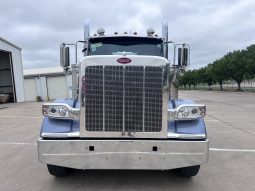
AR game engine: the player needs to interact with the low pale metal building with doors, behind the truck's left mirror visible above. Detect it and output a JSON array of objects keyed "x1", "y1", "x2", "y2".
[{"x1": 24, "y1": 67, "x2": 72, "y2": 101}]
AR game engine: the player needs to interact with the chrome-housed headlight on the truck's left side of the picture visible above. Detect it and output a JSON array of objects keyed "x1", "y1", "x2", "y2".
[{"x1": 42, "y1": 103, "x2": 80, "y2": 120}]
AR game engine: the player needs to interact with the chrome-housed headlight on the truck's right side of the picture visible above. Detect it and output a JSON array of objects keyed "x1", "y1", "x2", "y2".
[{"x1": 168, "y1": 104, "x2": 206, "y2": 120}]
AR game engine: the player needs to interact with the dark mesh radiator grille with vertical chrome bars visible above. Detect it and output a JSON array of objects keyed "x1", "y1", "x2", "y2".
[{"x1": 85, "y1": 65, "x2": 163, "y2": 133}]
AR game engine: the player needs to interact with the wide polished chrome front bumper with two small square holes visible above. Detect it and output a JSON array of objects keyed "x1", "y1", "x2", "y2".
[{"x1": 37, "y1": 138, "x2": 209, "y2": 170}]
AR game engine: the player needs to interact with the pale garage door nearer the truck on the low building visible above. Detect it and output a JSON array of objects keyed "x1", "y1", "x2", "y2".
[{"x1": 47, "y1": 76, "x2": 67, "y2": 100}]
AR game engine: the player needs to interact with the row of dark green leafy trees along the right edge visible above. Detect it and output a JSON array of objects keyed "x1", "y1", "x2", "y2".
[{"x1": 181, "y1": 45, "x2": 255, "y2": 91}]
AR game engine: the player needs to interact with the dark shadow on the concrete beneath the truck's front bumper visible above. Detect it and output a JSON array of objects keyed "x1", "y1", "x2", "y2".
[{"x1": 49, "y1": 170, "x2": 196, "y2": 190}]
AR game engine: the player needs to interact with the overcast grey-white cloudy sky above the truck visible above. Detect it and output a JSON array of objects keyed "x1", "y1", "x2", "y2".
[{"x1": 0, "y1": 0, "x2": 255, "y2": 69}]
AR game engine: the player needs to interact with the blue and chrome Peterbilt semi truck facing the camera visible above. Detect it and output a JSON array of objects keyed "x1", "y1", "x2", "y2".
[{"x1": 37, "y1": 21, "x2": 209, "y2": 177}]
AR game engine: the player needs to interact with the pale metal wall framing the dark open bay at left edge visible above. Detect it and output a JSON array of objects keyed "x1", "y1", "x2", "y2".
[{"x1": 0, "y1": 39, "x2": 25, "y2": 102}]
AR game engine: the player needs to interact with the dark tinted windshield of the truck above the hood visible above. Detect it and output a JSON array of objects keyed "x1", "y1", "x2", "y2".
[{"x1": 89, "y1": 37, "x2": 163, "y2": 56}]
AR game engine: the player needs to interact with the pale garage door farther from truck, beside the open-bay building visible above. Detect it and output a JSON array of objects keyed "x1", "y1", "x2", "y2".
[{"x1": 24, "y1": 78, "x2": 37, "y2": 101}]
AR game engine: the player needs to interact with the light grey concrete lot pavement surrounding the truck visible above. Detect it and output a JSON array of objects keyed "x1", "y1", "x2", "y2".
[{"x1": 0, "y1": 91, "x2": 255, "y2": 191}]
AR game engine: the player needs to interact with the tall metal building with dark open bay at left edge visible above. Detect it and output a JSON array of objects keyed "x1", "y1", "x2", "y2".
[{"x1": 0, "y1": 37, "x2": 24, "y2": 102}]
